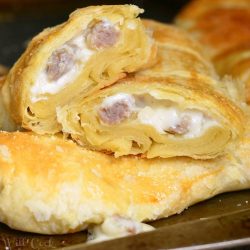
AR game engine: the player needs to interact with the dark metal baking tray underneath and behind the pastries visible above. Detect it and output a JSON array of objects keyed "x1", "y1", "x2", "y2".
[{"x1": 0, "y1": 0, "x2": 250, "y2": 250}]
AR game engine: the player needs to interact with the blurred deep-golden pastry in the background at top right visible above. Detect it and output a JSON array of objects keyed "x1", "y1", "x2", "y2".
[{"x1": 176, "y1": 0, "x2": 250, "y2": 103}]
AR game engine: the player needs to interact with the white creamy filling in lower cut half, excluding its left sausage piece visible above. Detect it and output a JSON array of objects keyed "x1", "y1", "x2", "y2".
[{"x1": 98, "y1": 93, "x2": 220, "y2": 138}]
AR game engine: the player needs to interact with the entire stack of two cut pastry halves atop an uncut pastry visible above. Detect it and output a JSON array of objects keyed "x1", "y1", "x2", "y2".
[{"x1": 0, "y1": 5, "x2": 250, "y2": 237}]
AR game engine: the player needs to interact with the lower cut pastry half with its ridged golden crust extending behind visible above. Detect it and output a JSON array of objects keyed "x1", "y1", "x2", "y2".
[{"x1": 57, "y1": 20, "x2": 244, "y2": 159}]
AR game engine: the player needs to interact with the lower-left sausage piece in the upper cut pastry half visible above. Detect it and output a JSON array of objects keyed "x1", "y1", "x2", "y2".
[{"x1": 46, "y1": 48, "x2": 75, "y2": 81}]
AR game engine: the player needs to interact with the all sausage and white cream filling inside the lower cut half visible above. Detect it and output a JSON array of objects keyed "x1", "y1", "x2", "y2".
[{"x1": 98, "y1": 93, "x2": 219, "y2": 138}]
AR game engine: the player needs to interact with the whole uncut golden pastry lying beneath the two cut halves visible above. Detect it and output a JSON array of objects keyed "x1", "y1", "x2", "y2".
[{"x1": 0, "y1": 116, "x2": 250, "y2": 234}]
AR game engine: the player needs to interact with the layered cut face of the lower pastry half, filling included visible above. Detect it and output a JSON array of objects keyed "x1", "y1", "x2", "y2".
[{"x1": 57, "y1": 76, "x2": 243, "y2": 159}]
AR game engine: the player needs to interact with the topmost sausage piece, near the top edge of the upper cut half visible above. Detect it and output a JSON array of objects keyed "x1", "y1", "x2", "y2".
[{"x1": 87, "y1": 21, "x2": 120, "y2": 49}]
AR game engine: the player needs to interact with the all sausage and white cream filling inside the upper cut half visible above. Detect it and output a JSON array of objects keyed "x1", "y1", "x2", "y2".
[{"x1": 31, "y1": 21, "x2": 120, "y2": 102}]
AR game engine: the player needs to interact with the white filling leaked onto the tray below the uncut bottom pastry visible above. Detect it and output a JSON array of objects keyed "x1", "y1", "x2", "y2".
[{"x1": 87, "y1": 215, "x2": 154, "y2": 243}]
